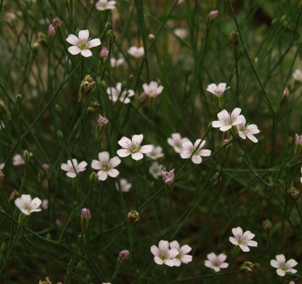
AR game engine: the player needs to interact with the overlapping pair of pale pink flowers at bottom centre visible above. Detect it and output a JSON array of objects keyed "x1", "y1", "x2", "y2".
[{"x1": 151, "y1": 240, "x2": 193, "y2": 267}]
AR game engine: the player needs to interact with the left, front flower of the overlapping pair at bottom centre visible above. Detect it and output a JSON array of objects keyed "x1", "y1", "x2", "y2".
[{"x1": 151, "y1": 240, "x2": 178, "y2": 267}]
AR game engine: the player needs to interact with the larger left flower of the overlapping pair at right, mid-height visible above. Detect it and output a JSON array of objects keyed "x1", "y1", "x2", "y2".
[{"x1": 212, "y1": 108, "x2": 245, "y2": 132}]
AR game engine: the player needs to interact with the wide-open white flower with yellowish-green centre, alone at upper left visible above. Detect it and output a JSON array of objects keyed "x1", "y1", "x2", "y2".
[{"x1": 66, "y1": 30, "x2": 101, "y2": 57}]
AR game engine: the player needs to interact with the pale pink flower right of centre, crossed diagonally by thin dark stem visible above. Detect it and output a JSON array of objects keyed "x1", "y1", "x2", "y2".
[{"x1": 180, "y1": 139, "x2": 211, "y2": 164}]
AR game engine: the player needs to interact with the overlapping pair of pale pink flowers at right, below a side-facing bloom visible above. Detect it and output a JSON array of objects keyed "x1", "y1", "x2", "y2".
[{"x1": 212, "y1": 108, "x2": 260, "y2": 143}]
